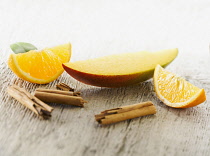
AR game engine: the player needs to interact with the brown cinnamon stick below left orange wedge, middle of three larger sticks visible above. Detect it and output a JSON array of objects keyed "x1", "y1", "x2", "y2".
[{"x1": 34, "y1": 89, "x2": 87, "y2": 107}]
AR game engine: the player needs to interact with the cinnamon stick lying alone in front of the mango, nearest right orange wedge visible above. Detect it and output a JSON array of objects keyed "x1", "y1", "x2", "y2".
[{"x1": 95, "y1": 101, "x2": 156, "y2": 125}]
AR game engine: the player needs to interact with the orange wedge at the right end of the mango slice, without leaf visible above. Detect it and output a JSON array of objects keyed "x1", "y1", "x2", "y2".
[{"x1": 153, "y1": 65, "x2": 206, "y2": 108}]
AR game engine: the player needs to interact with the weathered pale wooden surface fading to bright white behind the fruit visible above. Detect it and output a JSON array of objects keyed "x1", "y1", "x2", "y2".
[{"x1": 0, "y1": 0, "x2": 210, "y2": 156}]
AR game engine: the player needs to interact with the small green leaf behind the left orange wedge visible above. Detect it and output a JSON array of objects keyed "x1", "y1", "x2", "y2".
[{"x1": 10, "y1": 42, "x2": 37, "y2": 54}]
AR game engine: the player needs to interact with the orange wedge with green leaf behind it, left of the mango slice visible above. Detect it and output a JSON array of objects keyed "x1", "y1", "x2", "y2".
[{"x1": 8, "y1": 43, "x2": 71, "y2": 84}]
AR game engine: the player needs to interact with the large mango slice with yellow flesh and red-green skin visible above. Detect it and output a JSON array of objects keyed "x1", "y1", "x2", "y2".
[{"x1": 63, "y1": 49, "x2": 178, "y2": 87}]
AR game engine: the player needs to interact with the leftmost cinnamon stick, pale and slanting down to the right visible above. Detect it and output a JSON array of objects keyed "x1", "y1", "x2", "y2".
[{"x1": 7, "y1": 85, "x2": 53, "y2": 119}]
